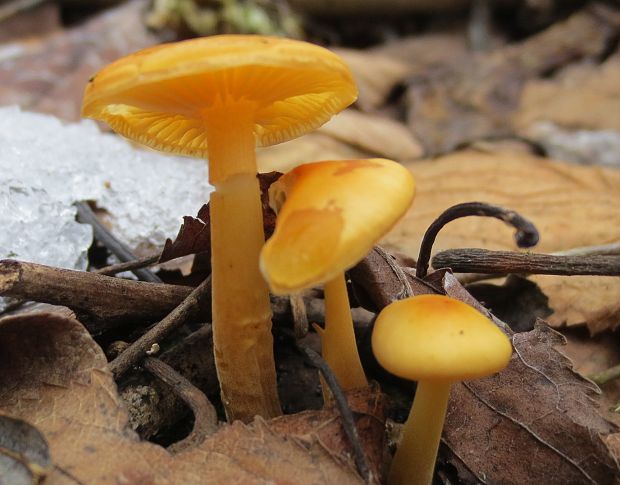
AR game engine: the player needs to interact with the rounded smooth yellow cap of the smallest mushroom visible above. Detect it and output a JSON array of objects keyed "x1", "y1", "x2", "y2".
[{"x1": 372, "y1": 295, "x2": 512, "y2": 381}]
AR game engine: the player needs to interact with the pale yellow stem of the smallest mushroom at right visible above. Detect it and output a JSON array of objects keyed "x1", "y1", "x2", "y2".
[{"x1": 388, "y1": 381, "x2": 450, "y2": 485}]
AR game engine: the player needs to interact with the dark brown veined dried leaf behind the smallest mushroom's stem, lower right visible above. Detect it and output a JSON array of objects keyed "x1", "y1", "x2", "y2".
[{"x1": 444, "y1": 324, "x2": 620, "y2": 485}]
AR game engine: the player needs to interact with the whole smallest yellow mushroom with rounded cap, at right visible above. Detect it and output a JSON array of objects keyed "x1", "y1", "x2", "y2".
[{"x1": 372, "y1": 295, "x2": 512, "y2": 485}]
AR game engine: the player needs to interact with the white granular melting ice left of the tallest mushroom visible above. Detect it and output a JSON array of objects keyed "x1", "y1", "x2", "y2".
[{"x1": 0, "y1": 107, "x2": 211, "y2": 269}]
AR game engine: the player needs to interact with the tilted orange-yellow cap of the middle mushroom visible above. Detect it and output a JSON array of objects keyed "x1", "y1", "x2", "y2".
[{"x1": 260, "y1": 158, "x2": 415, "y2": 294}]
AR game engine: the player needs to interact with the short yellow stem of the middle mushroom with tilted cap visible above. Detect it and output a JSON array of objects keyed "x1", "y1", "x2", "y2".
[{"x1": 321, "y1": 273, "x2": 368, "y2": 391}]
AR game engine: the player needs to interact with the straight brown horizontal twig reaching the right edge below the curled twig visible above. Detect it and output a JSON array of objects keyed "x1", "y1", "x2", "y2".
[{"x1": 433, "y1": 248, "x2": 620, "y2": 276}]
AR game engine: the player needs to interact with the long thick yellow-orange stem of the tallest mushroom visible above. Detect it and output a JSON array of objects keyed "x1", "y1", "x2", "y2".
[{"x1": 204, "y1": 102, "x2": 281, "y2": 422}]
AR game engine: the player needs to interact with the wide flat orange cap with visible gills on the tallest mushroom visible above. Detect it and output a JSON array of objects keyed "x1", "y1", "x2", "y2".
[{"x1": 82, "y1": 35, "x2": 357, "y2": 164}]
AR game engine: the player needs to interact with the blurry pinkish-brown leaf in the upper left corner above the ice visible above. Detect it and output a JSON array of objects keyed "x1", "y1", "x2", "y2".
[{"x1": 0, "y1": 0, "x2": 157, "y2": 120}]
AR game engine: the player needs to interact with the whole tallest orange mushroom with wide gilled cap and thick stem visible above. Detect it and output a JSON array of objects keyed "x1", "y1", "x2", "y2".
[{"x1": 82, "y1": 35, "x2": 357, "y2": 421}]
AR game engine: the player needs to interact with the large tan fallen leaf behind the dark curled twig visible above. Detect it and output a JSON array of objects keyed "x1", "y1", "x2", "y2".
[{"x1": 383, "y1": 150, "x2": 620, "y2": 333}]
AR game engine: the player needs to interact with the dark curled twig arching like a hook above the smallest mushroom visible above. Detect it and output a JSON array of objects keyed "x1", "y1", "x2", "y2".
[{"x1": 416, "y1": 202, "x2": 538, "y2": 278}]
